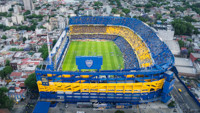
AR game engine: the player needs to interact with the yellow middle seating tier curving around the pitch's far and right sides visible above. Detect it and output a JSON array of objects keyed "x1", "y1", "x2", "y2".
[{"x1": 70, "y1": 25, "x2": 153, "y2": 67}]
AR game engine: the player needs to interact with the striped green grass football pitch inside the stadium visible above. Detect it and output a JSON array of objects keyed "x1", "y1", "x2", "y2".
[{"x1": 62, "y1": 41, "x2": 124, "y2": 71}]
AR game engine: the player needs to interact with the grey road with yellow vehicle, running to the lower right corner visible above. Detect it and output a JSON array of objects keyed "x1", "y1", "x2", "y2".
[{"x1": 171, "y1": 78, "x2": 200, "y2": 113}]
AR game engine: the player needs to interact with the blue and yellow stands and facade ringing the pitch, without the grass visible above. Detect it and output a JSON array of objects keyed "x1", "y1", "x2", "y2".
[{"x1": 35, "y1": 16, "x2": 175, "y2": 104}]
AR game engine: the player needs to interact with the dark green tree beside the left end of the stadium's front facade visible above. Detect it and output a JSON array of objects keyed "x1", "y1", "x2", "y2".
[{"x1": 24, "y1": 73, "x2": 38, "y2": 90}]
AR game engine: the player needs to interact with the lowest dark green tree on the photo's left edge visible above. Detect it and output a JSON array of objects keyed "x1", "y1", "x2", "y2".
[{"x1": 0, "y1": 87, "x2": 14, "y2": 109}]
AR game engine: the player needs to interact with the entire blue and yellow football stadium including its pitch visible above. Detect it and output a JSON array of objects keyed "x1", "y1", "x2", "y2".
[{"x1": 36, "y1": 16, "x2": 175, "y2": 104}]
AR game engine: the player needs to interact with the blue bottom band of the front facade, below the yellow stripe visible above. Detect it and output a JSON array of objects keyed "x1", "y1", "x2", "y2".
[{"x1": 40, "y1": 90, "x2": 170, "y2": 104}]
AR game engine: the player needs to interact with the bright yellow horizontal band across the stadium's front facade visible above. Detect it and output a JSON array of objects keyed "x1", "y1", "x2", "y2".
[{"x1": 37, "y1": 79, "x2": 164, "y2": 93}]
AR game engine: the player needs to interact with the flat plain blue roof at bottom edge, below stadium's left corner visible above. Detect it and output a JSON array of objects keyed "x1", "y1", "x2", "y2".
[{"x1": 33, "y1": 102, "x2": 50, "y2": 113}]
